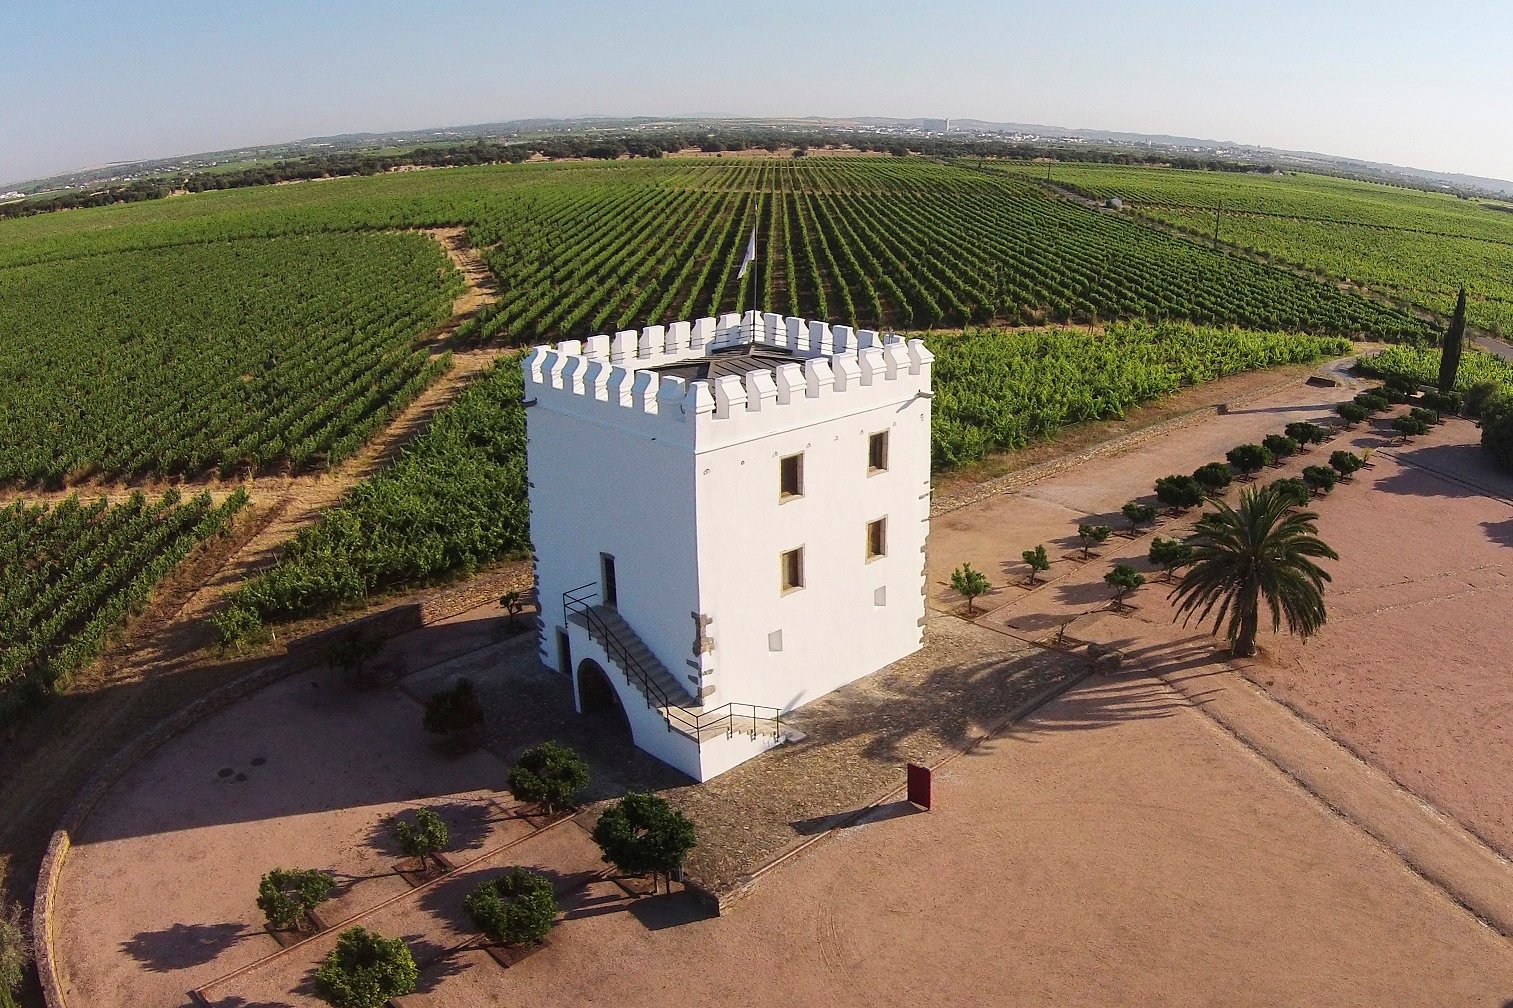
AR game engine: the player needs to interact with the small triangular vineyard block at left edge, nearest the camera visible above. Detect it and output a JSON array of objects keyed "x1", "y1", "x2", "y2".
[{"x1": 0, "y1": 490, "x2": 247, "y2": 717}]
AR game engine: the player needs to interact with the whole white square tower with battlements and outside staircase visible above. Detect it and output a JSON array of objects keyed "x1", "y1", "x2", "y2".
[{"x1": 523, "y1": 312, "x2": 932, "y2": 781}]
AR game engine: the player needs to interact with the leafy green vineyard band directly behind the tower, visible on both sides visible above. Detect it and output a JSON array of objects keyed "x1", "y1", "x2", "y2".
[{"x1": 216, "y1": 322, "x2": 1350, "y2": 642}]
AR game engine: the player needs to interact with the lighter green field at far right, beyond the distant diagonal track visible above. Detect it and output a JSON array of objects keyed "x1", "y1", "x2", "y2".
[{"x1": 1026, "y1": 165, "x2": 1513, "y2": 336}]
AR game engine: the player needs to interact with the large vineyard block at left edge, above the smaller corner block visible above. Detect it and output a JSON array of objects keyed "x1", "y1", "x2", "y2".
[{"x1": 0, "y1": 235, "x2": 461, "y2": 486}]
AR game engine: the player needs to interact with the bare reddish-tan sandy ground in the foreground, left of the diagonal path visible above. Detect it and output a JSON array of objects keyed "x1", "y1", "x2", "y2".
[{"x1": 402, "y1": 680, "x2": 1513, "y2": 1008}]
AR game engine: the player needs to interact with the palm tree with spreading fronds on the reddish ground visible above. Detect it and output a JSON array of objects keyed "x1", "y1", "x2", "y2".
[{"x1": 1171, "y1": 486, "x2": 1339, "y2": 655}]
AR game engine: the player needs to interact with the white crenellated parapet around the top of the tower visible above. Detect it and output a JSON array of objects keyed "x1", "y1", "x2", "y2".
[{"x1": 522, "y1": 312, "x2": 934, "y2": 451}]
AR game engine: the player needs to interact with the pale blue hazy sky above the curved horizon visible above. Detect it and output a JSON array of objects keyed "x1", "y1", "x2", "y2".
[{"x1": 0, "y1": 0, "x2": 1513, "y2": 182}]
